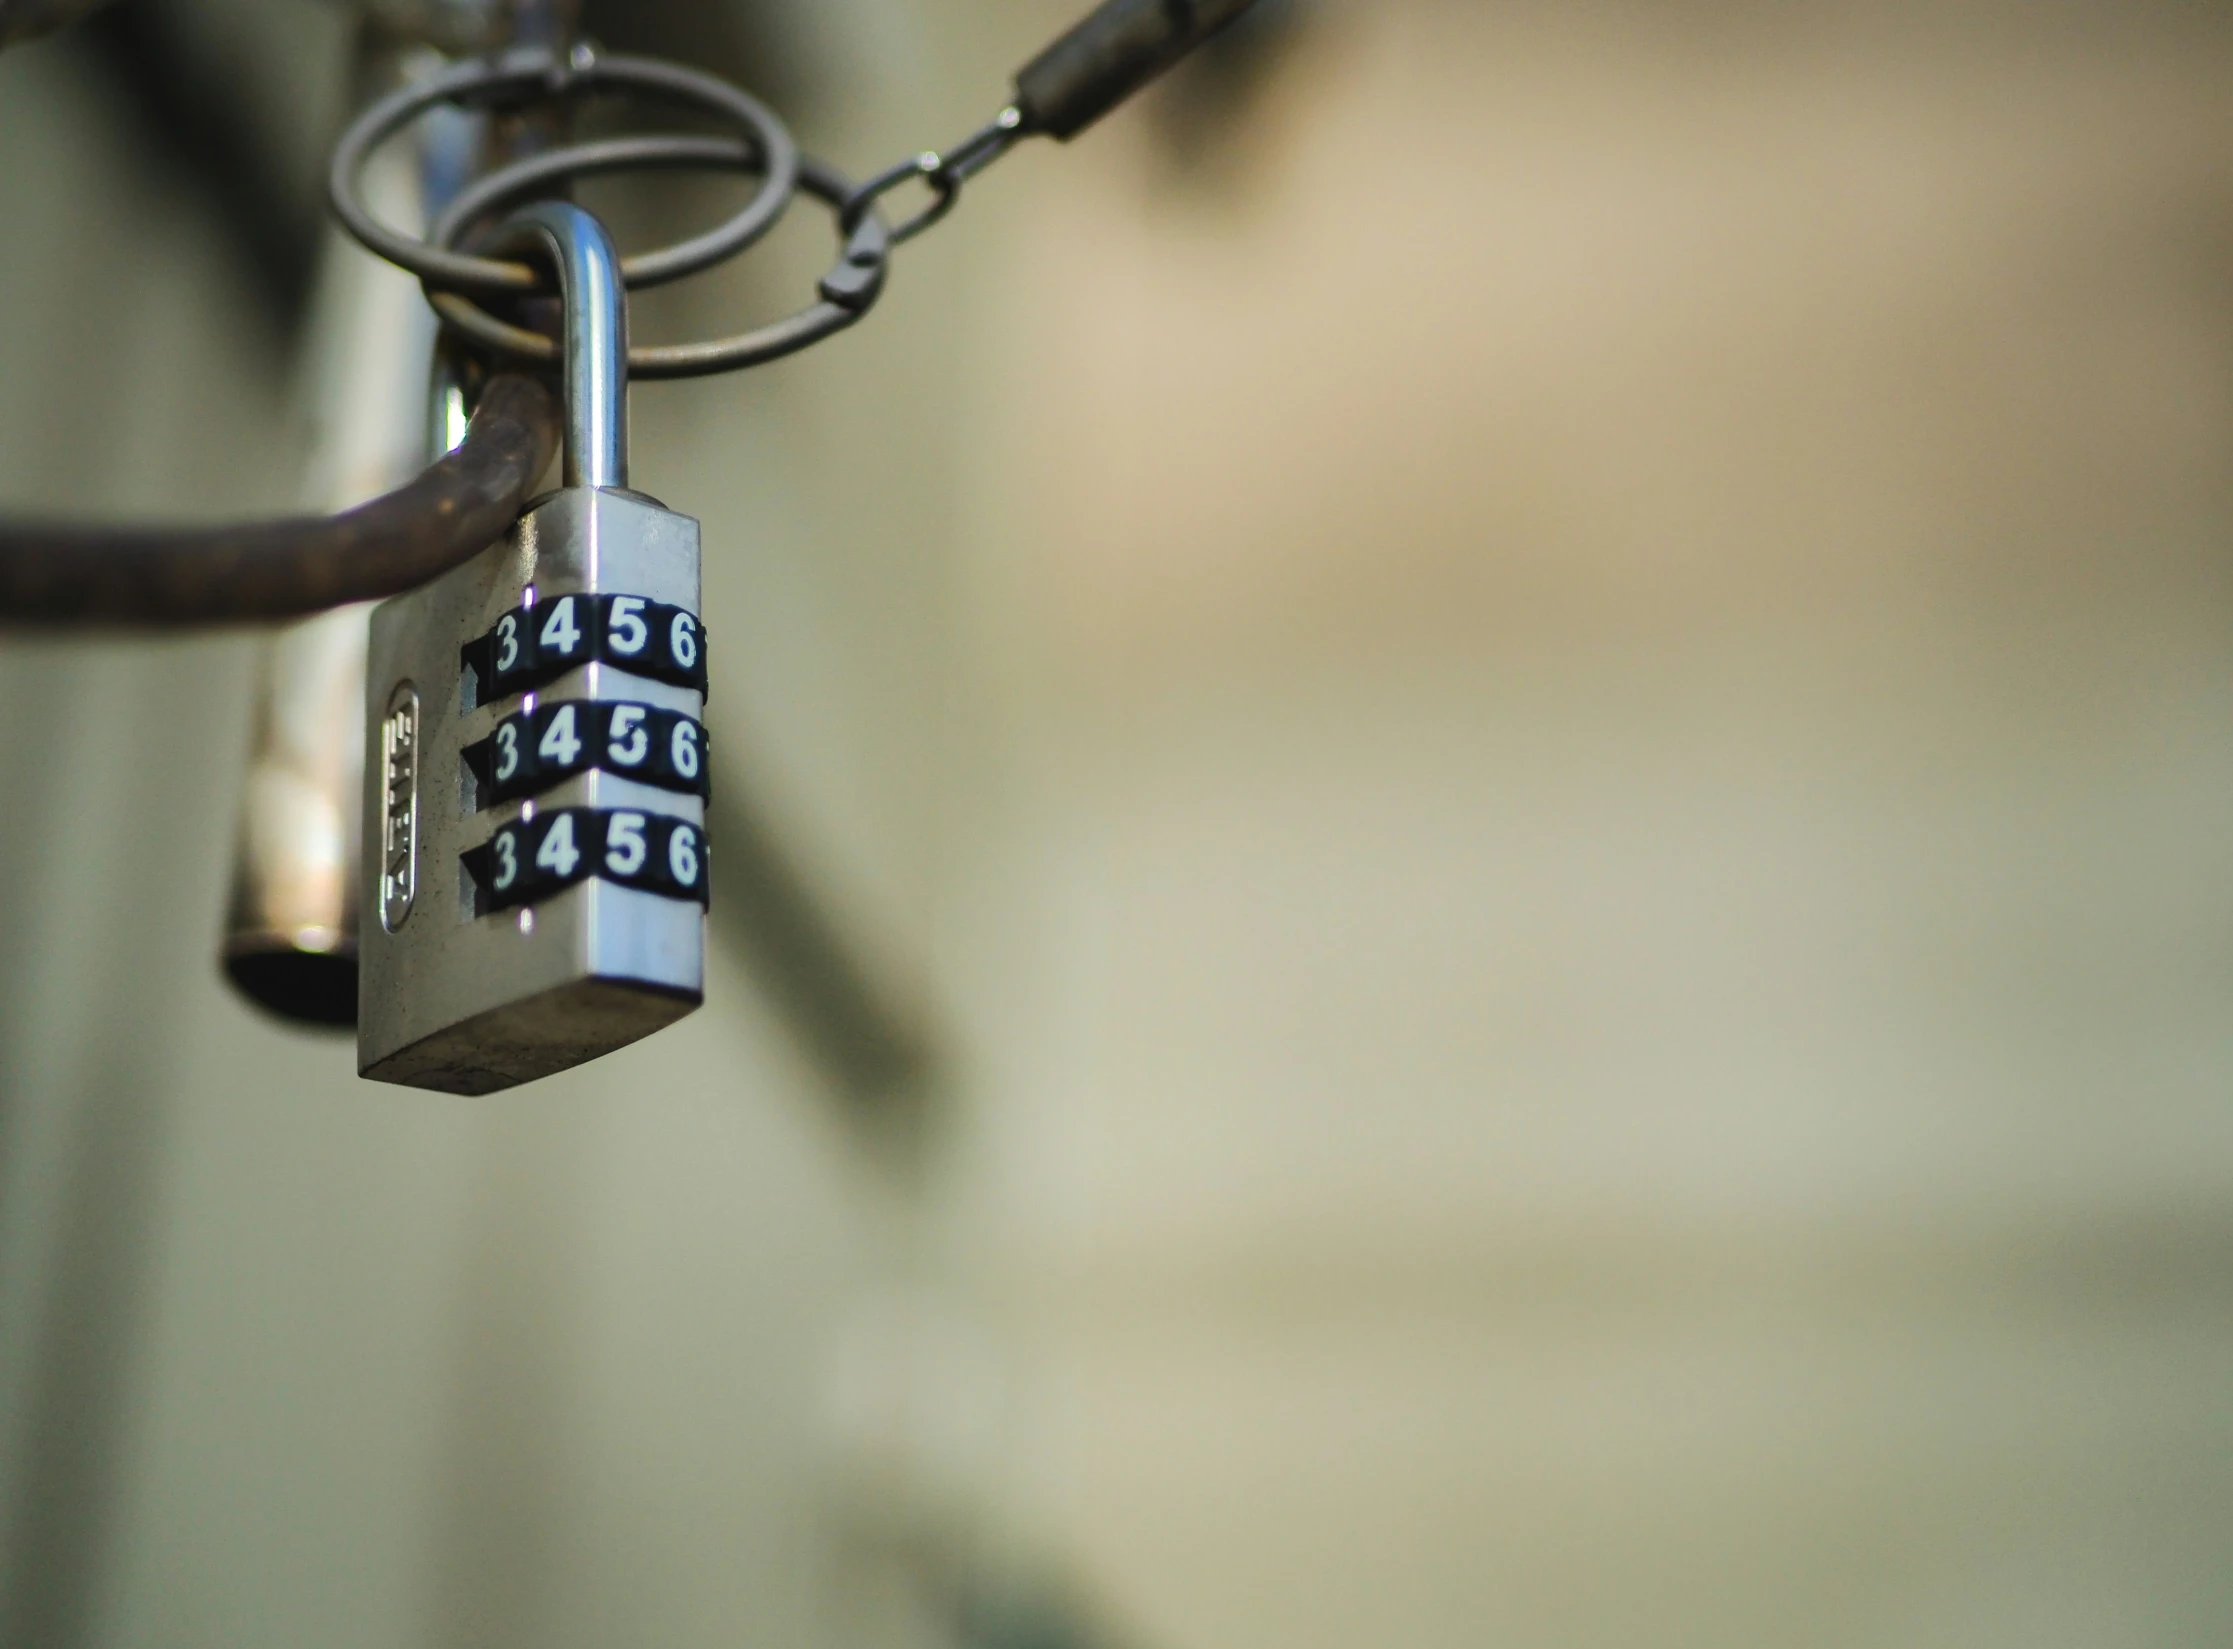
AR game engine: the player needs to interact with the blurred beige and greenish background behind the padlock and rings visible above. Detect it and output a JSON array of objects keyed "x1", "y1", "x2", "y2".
[{"x1": 0, "y1": 0, "x2": 2233, "y2": 1649}]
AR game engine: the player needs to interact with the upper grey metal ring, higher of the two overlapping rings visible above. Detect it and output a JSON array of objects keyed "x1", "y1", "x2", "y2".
[{"x1": 326, "y1": 47, "x2": 799, "y2": 293}]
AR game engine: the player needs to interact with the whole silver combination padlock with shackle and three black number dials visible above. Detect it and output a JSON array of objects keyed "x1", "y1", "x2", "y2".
[{"x1": 357, "y1": 201, "x2": 712, "y2": 1095}]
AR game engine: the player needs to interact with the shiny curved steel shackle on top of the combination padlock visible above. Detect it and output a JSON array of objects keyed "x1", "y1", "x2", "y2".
[{"x1": 496, "y1": 201, "x2": 627, "y2": 487}]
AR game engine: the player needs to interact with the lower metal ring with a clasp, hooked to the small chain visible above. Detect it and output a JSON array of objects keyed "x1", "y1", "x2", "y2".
[{"x1": 427, "y1": 136, "x2": 893, "y2": 380}]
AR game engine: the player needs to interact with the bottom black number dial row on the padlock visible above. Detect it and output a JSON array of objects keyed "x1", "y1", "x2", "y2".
[{"x1": 464, "y1": 807, "x2": 712, "y2": 916}]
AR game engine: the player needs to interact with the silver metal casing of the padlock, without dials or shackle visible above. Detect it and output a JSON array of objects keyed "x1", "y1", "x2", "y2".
[{"x1": 357, "y1": 487, "x2": 706, "y2": 1095}]
